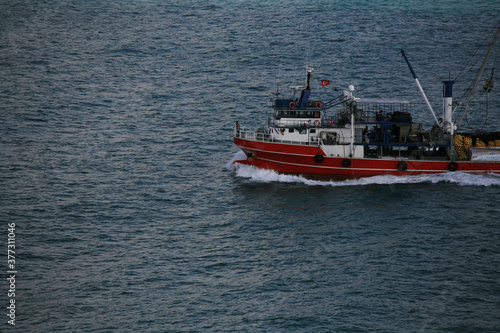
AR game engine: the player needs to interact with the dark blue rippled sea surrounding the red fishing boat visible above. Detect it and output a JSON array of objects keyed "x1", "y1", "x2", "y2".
[{"x1": 0, "y1": 0, "x2": 500, "y2": 332}]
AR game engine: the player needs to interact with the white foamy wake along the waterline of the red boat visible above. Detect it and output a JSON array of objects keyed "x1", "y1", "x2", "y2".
[{"x1": 225, "y1": 151, "x2": 500, "y2": 187}]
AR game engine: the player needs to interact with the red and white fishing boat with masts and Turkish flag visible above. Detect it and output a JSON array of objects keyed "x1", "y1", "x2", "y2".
[{"x1": 233, "y1": 22, "x2": 500, "y2": 179}]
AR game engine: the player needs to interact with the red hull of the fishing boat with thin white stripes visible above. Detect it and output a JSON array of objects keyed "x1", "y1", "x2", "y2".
[{"x1": 233, "y1": 137, "x2": 500, "y2": 179}]
